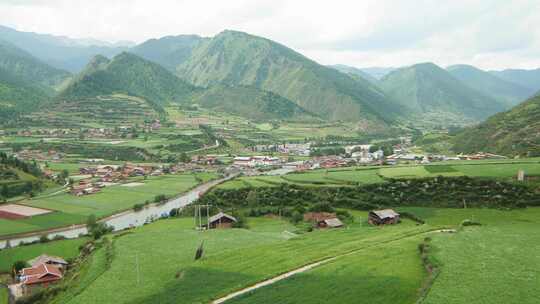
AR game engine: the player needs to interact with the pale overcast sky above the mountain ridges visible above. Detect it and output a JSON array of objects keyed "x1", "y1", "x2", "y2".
[{"x1": 0, "y1": 0, "x2": 540, "y2": 69}]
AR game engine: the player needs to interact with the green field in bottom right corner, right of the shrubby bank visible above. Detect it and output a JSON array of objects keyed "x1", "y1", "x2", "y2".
[{"x1": 423, "y1": 217, "x2": 540, "y2": 304}]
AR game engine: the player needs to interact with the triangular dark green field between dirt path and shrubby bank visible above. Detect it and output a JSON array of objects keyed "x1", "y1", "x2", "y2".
[{"x1": 230, "y1": 237, "x2": 425, "y2": 304}]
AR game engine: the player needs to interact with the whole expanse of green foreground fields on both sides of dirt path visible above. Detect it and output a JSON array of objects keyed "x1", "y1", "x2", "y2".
[{"x1": 40, "y1": 208, "x2": 540, "y2": 304}]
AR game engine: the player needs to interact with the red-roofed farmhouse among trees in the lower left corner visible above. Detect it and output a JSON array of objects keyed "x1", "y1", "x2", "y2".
[{"x1": 19, "y1": 263, "x2": 63, "y2": 295}]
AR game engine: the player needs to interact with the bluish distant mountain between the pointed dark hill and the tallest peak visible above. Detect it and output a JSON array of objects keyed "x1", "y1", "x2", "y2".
[{"x1": 129, "y1": 35, "x2": 204, "y2": 71}]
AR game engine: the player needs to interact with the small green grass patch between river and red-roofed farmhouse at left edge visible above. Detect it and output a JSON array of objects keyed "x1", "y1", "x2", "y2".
[{"x1": 0, "y1": 238, "x2": 88, "y2": 273}]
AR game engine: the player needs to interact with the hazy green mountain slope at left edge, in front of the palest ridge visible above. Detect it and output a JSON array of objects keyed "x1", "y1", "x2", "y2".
[{"x1": 0, "y1": 40, "x2": 70, "y2": 89}]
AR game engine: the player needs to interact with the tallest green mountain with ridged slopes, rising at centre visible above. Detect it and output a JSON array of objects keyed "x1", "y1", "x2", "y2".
[{"x1": 176, "y1": 31, "x2": 398, "y2": 125}]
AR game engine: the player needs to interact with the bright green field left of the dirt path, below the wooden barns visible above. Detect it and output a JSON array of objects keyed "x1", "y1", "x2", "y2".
[{"x1": 52, "y1": 219, "x2": 427, "y2": 303}]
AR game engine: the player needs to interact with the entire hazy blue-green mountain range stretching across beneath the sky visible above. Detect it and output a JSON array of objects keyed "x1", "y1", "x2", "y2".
[{"x1": 0, "y1": 27, "x2": 540, "y2": 128}]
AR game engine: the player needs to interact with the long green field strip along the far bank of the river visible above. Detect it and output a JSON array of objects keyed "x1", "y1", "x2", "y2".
[{"x1": 0, "y1": 173, "x2": 216, "y2": 236}]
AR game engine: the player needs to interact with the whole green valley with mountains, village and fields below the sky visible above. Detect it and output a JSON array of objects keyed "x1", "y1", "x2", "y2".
[{"x1": 0, "y1": 14, "x2": 540, "y2": 304}]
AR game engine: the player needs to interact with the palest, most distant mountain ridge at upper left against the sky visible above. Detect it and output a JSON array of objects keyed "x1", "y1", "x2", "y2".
[{"x1": 0, "y1": 26, "x2": 128, "y2": 73}]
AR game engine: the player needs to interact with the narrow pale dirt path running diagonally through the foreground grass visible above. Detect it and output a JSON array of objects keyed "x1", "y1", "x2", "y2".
[{"x1": 211, "y1": 229, "x2": 455, "y2": 304}]
